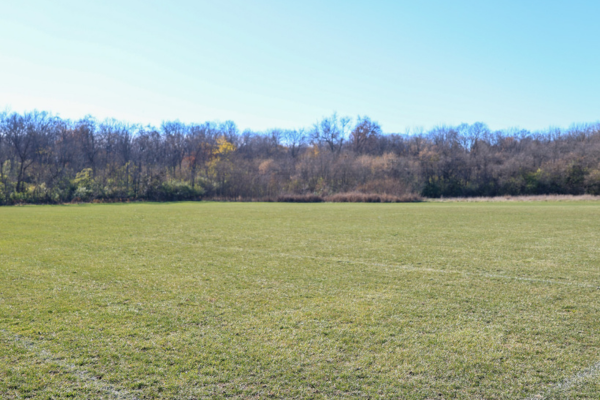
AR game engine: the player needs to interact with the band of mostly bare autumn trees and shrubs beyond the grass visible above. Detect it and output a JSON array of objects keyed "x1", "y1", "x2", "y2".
[{"x1": 0, "y1": 111, "x2": 600, "y2": 204}]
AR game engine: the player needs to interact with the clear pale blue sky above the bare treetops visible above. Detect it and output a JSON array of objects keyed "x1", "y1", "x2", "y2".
[{"x1": 0, "y1": 0, "x2": 600, "y2": 132}]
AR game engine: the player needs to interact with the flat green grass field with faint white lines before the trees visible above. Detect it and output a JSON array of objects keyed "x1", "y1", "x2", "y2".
[{"x1": 0, "y1": 202, "x2": 600, "y2": 399}]
